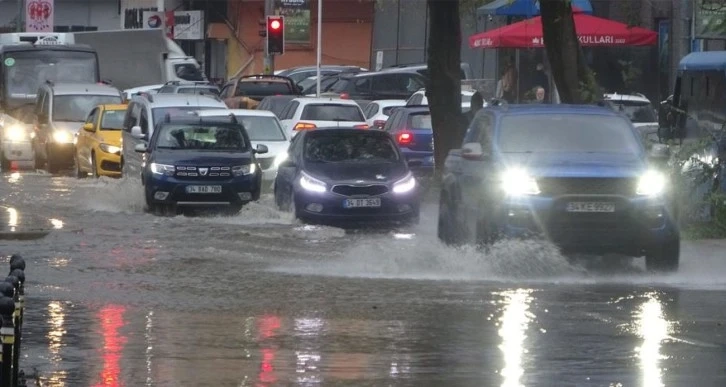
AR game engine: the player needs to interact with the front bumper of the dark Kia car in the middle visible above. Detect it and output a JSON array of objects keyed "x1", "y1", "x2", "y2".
[{"x1": 295, "y1": 188, "x2": 420, "y2": 223}]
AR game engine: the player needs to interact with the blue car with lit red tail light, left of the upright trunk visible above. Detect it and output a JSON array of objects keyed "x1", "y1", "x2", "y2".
[{"x1": 383, "y1": 106, "x2": 434, "y2": 177}]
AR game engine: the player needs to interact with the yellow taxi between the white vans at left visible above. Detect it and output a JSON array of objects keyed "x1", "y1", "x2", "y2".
[{"x1": 76, "y1": 105, "x2": 128, "y2": 178}]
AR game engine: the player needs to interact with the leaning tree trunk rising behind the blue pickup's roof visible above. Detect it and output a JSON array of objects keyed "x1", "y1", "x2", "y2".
[{"x1": 540, "y1": 0, "x2": 602, "y2": 104}]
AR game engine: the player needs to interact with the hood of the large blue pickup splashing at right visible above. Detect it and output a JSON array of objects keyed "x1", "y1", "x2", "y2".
[{"x1": 504, "y1": 153, "x2": 647, "y2": 177}]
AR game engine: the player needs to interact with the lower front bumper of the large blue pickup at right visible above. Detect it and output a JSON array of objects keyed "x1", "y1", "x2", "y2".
[{"x1": 496, "y1": 197, "x2": 678, "y2": 256}]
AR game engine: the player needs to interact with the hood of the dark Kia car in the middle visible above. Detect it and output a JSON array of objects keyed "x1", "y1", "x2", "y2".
[{"x1": 305, "y1": 162, "x2": 408, "y2": 184}]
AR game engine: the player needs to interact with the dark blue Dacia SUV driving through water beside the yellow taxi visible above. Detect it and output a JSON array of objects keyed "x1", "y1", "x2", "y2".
[{"x1": 136, "y1": 116, "x2": 267, "y2": 215}]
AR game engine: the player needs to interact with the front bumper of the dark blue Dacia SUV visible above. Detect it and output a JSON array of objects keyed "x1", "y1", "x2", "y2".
[{"x1": 144, "y1": 174, "x2": 260, "y2": 207}]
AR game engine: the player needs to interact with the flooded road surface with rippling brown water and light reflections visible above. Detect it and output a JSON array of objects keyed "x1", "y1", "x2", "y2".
[{"x1": 0, "y1": 174, "x2": 726, "y2": 387}]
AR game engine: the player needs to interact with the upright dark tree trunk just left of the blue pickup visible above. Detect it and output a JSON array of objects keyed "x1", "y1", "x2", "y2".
[{"x1": 426, "y1": 0, "x2": 465, "y2": 171}]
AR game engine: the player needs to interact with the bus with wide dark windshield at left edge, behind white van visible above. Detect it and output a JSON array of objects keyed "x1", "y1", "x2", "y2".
[{"x1": 0, "y1": 33, "x2": 100, "y2": 170}]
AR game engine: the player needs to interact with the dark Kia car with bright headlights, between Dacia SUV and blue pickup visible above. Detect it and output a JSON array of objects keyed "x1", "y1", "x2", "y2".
[{"x1": 275, "y1": 128, "x2": 420, "y2": 224}]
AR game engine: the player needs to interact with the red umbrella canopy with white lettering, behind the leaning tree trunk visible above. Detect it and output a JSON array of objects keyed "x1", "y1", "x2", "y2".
[{"x1": 469, "y1": 13, "x2": 658, "y2": 48}]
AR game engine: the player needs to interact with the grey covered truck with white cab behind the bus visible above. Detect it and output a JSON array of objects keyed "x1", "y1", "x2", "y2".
[{"x1": 73, "y1": 29, "x2": 208, "y2": 90}]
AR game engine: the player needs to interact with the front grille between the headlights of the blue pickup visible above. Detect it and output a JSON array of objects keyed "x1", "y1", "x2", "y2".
[{"x1": 537, "y1": 178, "x2": 637, "y2": 195}]
